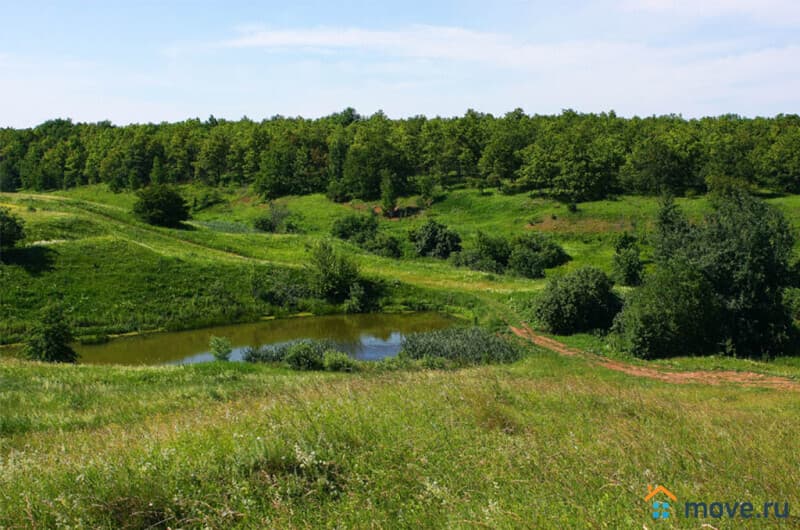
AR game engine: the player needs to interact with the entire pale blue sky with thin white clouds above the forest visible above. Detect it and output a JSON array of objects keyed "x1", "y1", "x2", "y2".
[{"x1": 0, "y1": 0, "x2": 800, "y2": 127}]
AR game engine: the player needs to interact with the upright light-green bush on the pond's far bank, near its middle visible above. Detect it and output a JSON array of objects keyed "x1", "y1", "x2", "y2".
[{"x1": 308, "y1": 241, "x2": 359, "y2": 302}]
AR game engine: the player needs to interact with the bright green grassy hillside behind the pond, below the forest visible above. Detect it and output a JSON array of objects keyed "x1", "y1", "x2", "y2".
[{"x1": 0, "y1": 186, "x2": 788, "y2": 343}]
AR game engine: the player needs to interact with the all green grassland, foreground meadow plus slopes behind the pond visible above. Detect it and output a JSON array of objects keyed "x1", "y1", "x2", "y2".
[{"x1": 0, "y1": 186, "x2": 800, "y2": 529}]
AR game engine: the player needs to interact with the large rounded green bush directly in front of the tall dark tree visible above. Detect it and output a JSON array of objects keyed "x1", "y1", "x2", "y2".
[{"x1": 614, "y1": 263, "x2": 722, "y2": 359}]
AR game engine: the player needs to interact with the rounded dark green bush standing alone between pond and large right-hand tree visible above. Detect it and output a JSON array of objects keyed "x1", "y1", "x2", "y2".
[{"x1": 533, "y1": 267, "x2": 621, "y2": 335}]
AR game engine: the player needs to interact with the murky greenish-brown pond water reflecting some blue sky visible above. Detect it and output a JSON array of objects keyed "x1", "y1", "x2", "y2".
[{"x1": 75, "y1": 313, "x2": 454, "y2": 365}]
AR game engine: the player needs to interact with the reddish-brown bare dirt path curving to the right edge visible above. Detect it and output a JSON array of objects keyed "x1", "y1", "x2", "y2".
[{"x1": 511, "y1": 324, "x2": 800, "y2": 391}]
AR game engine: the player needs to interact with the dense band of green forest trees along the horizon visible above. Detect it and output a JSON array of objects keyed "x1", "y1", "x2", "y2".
[{"x1": 0, "y1": 108, "x2": 800, "y2": 203}]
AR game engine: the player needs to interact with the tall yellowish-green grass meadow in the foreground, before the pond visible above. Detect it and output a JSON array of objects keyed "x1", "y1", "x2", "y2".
[{"x1": 0, "y1": 348, "x2": 800, "y2": 528}]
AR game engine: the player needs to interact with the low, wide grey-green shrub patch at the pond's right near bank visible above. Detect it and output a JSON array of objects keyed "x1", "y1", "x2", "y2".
[{"x1": 400, "y1": 327, "x2": 520, "y2": 366}]
